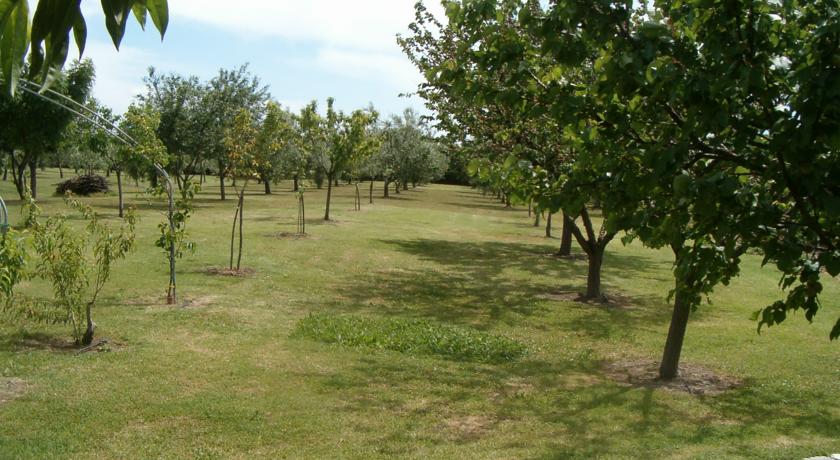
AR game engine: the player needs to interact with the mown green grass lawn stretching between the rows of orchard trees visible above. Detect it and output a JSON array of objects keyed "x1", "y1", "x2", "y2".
[{"x1": 0, "y1": 171, "x2": 840, "y2": 459}]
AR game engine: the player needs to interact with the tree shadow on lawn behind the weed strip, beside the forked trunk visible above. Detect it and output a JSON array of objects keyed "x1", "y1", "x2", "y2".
[{"x1": 337, "y1": 239, "x2": 668, "y2": 337}]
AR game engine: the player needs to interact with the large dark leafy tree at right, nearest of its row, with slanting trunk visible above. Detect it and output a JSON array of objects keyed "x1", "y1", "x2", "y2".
[{"x1": 418, "y1": 0, "x2": 840, "y2": 379}]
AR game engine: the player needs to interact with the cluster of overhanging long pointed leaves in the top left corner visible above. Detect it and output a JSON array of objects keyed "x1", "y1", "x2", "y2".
[{"x1": 0, "y1": 0, "x2": 169, "y2": 95}]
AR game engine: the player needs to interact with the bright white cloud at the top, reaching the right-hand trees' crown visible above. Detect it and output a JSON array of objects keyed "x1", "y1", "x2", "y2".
[{"x1": 169, "y1": 0, "x2": 443, "y2": 95}]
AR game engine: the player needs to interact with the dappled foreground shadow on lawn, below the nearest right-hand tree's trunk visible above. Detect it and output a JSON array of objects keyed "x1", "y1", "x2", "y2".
[{"x1": 322, "y1": 355, "x2": 840, "y2": 458}]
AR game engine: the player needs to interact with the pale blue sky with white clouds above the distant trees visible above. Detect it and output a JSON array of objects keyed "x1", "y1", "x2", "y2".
[{"x1": 82, "y1": 0, "x2": 441, "y2": 115}]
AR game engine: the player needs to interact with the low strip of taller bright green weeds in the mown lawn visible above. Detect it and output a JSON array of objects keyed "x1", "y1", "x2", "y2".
[{"x1": 293, "y1": 314, "x2": 526, "y2": 363}]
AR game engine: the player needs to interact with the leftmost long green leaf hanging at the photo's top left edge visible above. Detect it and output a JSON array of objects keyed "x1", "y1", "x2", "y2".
[{"x1": 0, "y1": 0, "x2": 29, "y2": 94}]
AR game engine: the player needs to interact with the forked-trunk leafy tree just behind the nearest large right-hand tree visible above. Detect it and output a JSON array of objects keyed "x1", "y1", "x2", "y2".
[{"x1": 400, "y1": 1, "x2": 604, "y2": 299}]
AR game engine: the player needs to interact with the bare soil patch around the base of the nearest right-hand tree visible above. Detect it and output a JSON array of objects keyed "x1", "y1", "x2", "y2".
[{"x1": 603, "y1": 360, "x2": 743, "y2": 396}]
